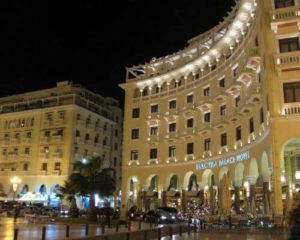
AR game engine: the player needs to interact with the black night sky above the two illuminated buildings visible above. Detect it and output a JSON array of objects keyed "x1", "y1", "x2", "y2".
[{"x1": 0, "y1": 0, "x2": 234, "y2": 107}]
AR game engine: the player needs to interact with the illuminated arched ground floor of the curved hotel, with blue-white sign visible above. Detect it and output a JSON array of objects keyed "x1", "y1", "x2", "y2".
[{"x1": 121, "y1": 122, "x2": 300, "y2": 217}]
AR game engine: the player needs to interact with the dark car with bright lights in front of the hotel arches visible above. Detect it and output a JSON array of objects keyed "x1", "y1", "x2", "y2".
[{"x1": 146, "y1": 207, "x2": 178, "y2": 223}]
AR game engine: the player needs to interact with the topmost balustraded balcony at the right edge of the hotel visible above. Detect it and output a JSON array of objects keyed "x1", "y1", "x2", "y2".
[{"x1": 270, "y1": 6, "x2": 300, "y2": 33}]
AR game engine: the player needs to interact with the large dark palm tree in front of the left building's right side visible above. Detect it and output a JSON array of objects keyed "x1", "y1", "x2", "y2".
[{"x1": 61, "y1": 157, "x2": 116, "y2": 221}]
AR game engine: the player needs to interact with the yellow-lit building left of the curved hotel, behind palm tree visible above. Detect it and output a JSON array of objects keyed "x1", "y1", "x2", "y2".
[{"x1": 0, "y1": 81, "x2": 123, "y2": 206}]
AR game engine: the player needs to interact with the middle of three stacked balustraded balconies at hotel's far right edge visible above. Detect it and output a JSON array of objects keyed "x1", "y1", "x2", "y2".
[{"x1": 274, "y1": 51, "x2": 300, "y2": 72}]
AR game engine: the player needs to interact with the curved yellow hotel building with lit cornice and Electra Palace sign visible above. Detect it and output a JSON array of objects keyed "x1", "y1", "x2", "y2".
[{"x1": 121, "y1": 0, "x2": 300, "y2": 217}]
